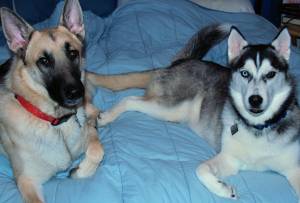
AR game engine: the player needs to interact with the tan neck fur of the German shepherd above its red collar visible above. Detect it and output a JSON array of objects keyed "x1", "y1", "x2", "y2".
[{"x1": 6, "y1": 59, "x2": 76, "y2": 117}]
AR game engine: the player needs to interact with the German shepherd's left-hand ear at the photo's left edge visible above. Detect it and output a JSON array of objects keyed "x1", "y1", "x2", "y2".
[{"x1": 0, "y1": 7, "x2": 34, "y2": 53}]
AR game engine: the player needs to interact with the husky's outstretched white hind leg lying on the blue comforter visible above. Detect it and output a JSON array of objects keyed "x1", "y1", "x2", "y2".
[{"x1": 98, "y1": 96, "x2": 197, "y2": 126}]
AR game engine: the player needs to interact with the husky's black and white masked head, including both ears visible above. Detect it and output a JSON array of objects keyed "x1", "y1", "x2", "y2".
[{"x1": 228, "y1": 28, "x2": 292, "y2": 125}]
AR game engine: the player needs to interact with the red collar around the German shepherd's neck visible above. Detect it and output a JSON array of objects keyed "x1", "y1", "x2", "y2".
[{"x1": 15, "y1": 95, "x2": 74, "y2": 126}]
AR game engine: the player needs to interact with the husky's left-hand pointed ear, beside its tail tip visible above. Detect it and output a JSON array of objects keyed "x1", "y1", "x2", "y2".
[{"x1": 228, "y1": 27, "x2": 248, "y2": 62}]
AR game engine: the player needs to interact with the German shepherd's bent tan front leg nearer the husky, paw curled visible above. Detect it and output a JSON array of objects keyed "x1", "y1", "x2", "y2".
[{"x1": 71, "y1": 103, "x2": 104, "y2": 178}]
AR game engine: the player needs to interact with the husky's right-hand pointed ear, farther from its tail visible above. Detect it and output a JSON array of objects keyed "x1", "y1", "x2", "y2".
[{"x1": 272, "y1": 27, "x2": 291, "y2": 61}]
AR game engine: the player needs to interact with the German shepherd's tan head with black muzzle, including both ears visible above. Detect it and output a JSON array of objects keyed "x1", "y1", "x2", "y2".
[{"x1": 2, "y1": 1, "x2": 84, "y2": 108}]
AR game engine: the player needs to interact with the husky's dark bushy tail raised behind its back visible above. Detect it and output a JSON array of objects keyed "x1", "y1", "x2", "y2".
[{"x1": 173, "y1": 24, "x2": 231, "y2": 61}]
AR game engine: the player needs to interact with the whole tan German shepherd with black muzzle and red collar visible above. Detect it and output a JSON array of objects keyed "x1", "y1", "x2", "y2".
[{"x1": 0, "y1": 0, "x2": 104, "y2": 203}]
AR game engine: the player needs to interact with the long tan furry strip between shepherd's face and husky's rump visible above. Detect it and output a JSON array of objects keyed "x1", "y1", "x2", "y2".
[{"x1": 86, "y1": 71, "x2": 155, "y2": 91}]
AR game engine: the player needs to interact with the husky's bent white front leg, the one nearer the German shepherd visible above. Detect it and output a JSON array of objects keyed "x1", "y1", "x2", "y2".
[{"x1": 196, "y1": 153, "x2": 239, "y2": 199}]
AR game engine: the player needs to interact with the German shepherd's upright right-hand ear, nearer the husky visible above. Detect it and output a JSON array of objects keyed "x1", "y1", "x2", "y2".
[{"x1": 60, "y1": 0, "x2": 85, "y2": 39}]
